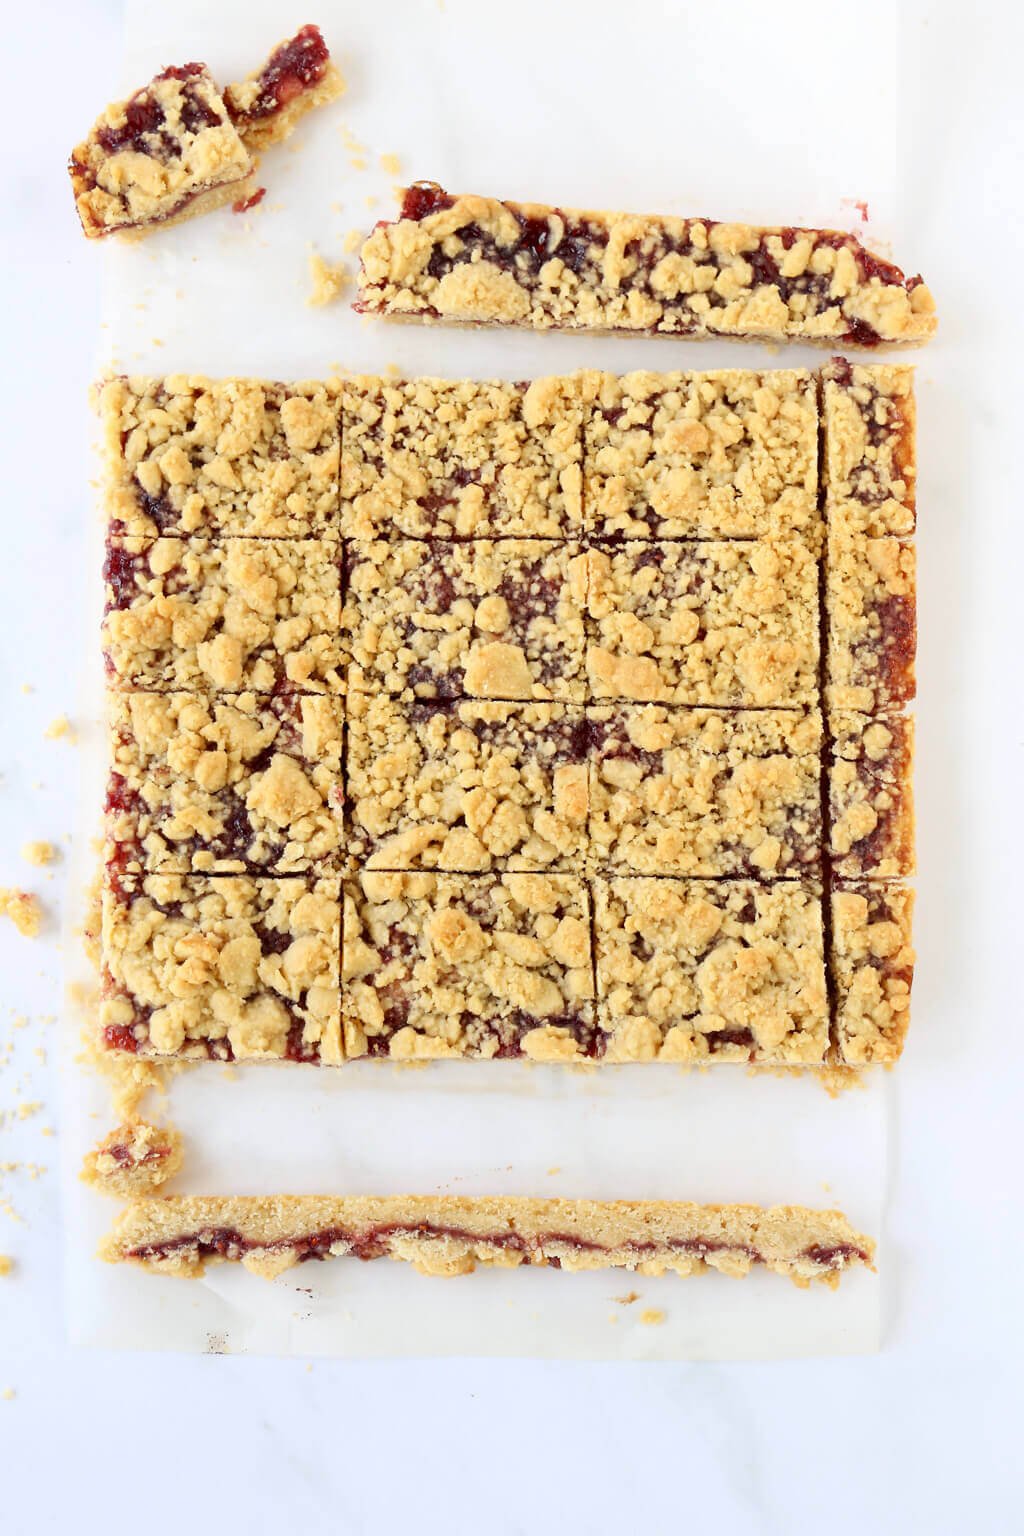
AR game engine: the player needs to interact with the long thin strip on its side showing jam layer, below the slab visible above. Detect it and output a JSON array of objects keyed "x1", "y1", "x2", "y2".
[{"x1": 100, "y1": 1195, "x2": 875, "y2": 1287}]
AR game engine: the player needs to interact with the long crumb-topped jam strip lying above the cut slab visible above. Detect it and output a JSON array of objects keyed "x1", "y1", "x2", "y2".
[{"x1": 356, "y1": 181, "x2": 935, "y2": 347}]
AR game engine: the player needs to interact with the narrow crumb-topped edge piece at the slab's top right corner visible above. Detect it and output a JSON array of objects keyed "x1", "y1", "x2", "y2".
[{"x1": 821, "y1": 358, "x2": 917, "y2": 538}]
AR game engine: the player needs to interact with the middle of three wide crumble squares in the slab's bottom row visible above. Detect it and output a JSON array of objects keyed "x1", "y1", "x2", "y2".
[{"x1": 342, "y1": 871, "x2": 603, "y2": 1061}]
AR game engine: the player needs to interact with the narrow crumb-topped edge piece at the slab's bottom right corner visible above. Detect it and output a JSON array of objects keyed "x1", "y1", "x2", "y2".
[{"x1": 829, "y1": 882, "x2": 913, "y2": 1066}]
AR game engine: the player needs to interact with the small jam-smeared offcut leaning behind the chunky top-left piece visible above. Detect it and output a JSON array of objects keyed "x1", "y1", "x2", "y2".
[{"x1": 224, "y1": 25, "x2": 345, "y2": 152}]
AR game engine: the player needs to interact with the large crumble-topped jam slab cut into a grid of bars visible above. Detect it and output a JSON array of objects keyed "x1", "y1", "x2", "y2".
[{"x1": 92, "y1": 359, "x2": 915, "y2": 1064}]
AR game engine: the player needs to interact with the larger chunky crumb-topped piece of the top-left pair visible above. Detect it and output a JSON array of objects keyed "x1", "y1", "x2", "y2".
[{"x1": 68, "y1": 65, "x2": 253, "y2": 240}]
